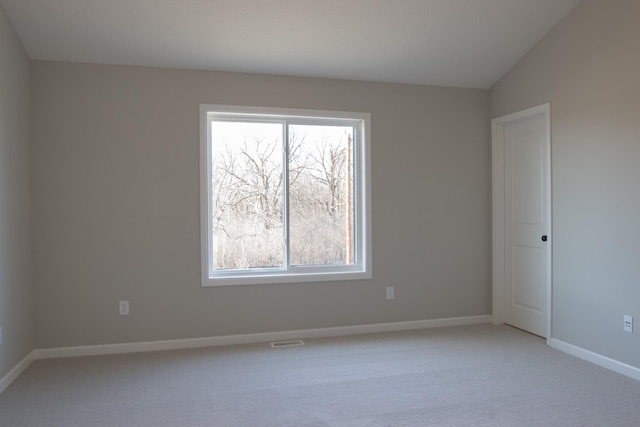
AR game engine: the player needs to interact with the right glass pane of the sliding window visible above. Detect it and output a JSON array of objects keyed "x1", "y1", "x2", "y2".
[{"x1": 289, "y1": 125, "x2": 354, "y2": 266}]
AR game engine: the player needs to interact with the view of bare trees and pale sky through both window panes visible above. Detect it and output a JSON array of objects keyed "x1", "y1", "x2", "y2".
[{"x1": 211, "y1": 120, "x2": 354, "y2": 270}]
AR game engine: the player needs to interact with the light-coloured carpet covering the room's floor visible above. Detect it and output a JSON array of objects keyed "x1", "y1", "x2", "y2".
[{"x1": 0, "y1": 325, "x2": 640, "y2": 427}]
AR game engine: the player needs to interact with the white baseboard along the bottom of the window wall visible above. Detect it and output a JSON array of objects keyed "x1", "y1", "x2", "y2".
[{"x1": 34, "y1": 315, "x2": 491, "y2": 359}]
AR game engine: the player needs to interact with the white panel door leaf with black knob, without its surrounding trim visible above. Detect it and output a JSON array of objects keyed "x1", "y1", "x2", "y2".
[{"x1": 504, "y1": 115, "x2": 548, "y2": 336}]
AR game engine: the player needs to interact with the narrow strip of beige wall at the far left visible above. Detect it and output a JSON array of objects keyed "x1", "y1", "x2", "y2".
[{"x1": 0, "y1": 5, "x2": 34, "y2": 378}]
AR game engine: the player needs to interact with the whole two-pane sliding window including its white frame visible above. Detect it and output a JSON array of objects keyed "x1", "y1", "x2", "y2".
[{"x1": 200, "y1": 105, "x2": 371, "y2": 286}]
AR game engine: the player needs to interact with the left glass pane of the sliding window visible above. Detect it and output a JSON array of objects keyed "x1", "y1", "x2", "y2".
[{"x1": 211, "y1": 121, "x2": 284, "y2": 270}]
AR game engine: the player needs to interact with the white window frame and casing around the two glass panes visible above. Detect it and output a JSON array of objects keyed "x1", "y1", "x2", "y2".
[{"x1": 200, "y1": 104, "x2": 372, "y2": 287}]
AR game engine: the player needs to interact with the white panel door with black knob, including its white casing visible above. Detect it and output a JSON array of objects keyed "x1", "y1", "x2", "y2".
[{"x1": 493, "y1": 105, "x2": 551, "y2": 337}]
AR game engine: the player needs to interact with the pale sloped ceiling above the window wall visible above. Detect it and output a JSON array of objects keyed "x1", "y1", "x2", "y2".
[{"x1": 0, "y1": 0, "x2": 580, "y2": 89}]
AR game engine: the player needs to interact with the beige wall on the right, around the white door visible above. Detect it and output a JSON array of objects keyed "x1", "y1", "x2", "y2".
[{"x1": 491, "y1": 0, "x2": 640, "y2": 368}]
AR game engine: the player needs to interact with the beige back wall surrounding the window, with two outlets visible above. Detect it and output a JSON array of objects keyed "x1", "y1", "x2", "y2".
[{"x1": 32, "y1": 61, "x2": 491, "y2": 347}]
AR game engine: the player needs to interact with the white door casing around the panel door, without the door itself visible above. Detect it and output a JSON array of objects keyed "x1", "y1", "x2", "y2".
[{"x1": 491, "y1": 103, "x2": 553, "y2": 343}]
